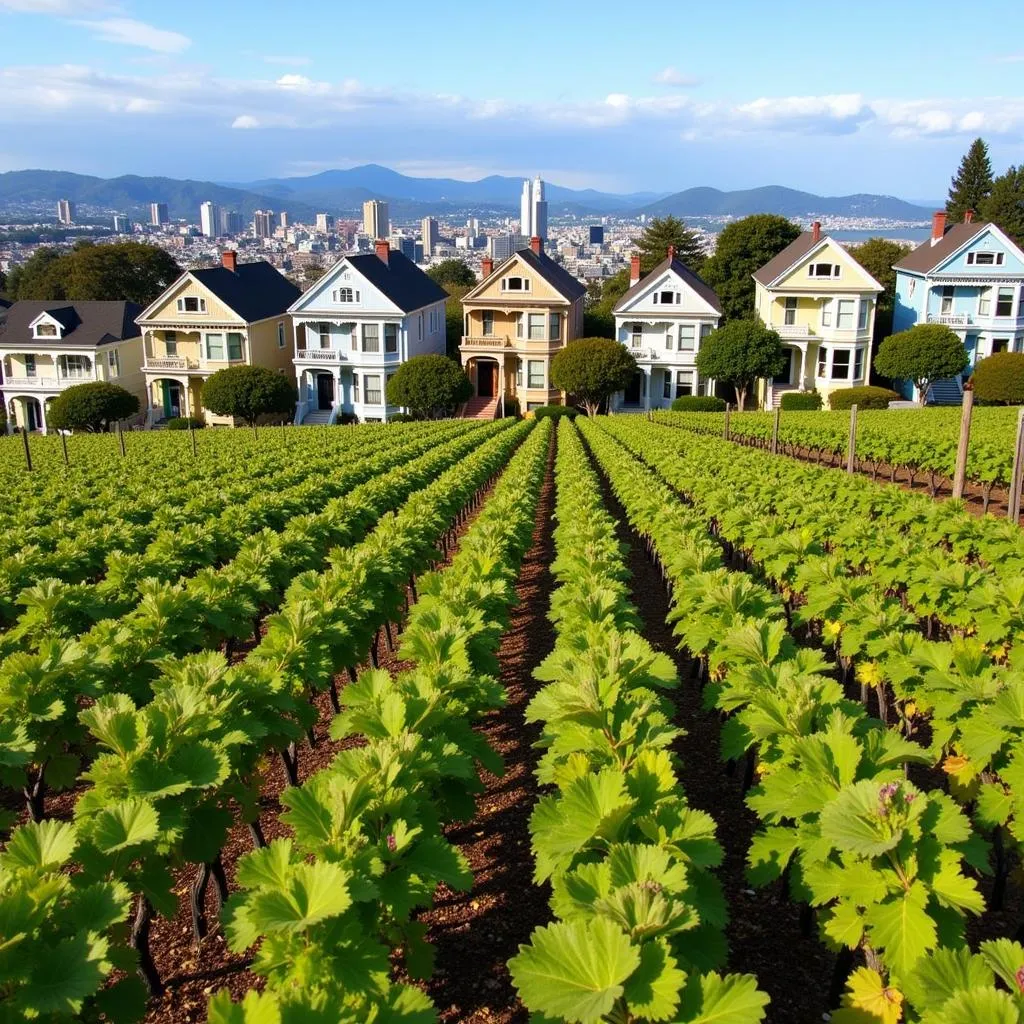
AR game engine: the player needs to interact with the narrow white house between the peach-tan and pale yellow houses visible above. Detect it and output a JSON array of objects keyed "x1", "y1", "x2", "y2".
[{"x1": 611, "y1": 246, "x2": 722, "y2": 410}]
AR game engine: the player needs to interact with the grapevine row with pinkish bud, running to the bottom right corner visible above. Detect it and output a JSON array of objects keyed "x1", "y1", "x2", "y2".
[{"x1": 584, "y1": 423, "x2": 1024, "y2": 1024}]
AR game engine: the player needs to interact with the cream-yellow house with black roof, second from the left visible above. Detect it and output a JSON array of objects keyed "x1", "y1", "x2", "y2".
[{"x1": 136, "y1": 250, "x2": 299, "y2": 426}]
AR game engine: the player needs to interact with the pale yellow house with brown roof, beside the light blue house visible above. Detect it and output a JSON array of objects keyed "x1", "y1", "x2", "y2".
[{"x1": 754, "y1": 221, "x2": 883, "y2": 409}]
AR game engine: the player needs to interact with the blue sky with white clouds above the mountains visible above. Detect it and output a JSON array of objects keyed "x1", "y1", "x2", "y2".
[{"x1": 0, "y1": 0, "x2": 1024, "y2": 199}]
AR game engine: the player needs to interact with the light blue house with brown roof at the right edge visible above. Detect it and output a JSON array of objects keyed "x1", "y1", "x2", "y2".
[{"x1": 893, "y1": 213, "x2": 1024, "y2": 403}]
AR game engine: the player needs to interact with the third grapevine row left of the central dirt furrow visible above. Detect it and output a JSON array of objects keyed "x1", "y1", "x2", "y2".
[{"x1": 0, "y1": 411, "x2": 495, "y2": 818}]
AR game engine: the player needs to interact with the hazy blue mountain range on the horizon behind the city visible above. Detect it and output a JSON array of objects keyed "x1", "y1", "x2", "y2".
[{"x1": 0, "y1": 164, "x2": 931, "y2": 222}]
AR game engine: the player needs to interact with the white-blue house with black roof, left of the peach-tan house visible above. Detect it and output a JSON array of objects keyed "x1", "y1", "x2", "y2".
[{"x1": 289, "y1": 242, "x2": 447, "y2": 424}]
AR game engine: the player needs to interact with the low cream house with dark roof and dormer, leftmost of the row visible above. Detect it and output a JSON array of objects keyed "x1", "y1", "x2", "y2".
[{"x1": 0, "y1": 300, "x2": 145, "y2": 433}]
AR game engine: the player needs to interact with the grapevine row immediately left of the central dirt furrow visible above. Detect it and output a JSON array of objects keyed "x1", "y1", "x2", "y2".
[{"x1": 209, "y1": 422, "x2": 551, "y2": 1024}]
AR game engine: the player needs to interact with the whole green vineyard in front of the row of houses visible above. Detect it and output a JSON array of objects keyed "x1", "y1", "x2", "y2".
[{"x1": 0, "y1": 409, "x2": 1024, "y2": 1024}]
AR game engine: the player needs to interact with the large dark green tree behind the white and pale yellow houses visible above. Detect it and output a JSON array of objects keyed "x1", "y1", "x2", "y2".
[{"x1": 700, "y1": 213, "x2": 800, "y2": 319}]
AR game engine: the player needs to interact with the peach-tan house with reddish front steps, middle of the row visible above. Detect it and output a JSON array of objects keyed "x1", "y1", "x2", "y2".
[{"x1": 460, "y1": 238, "x2": 587, "y2": 417}]
